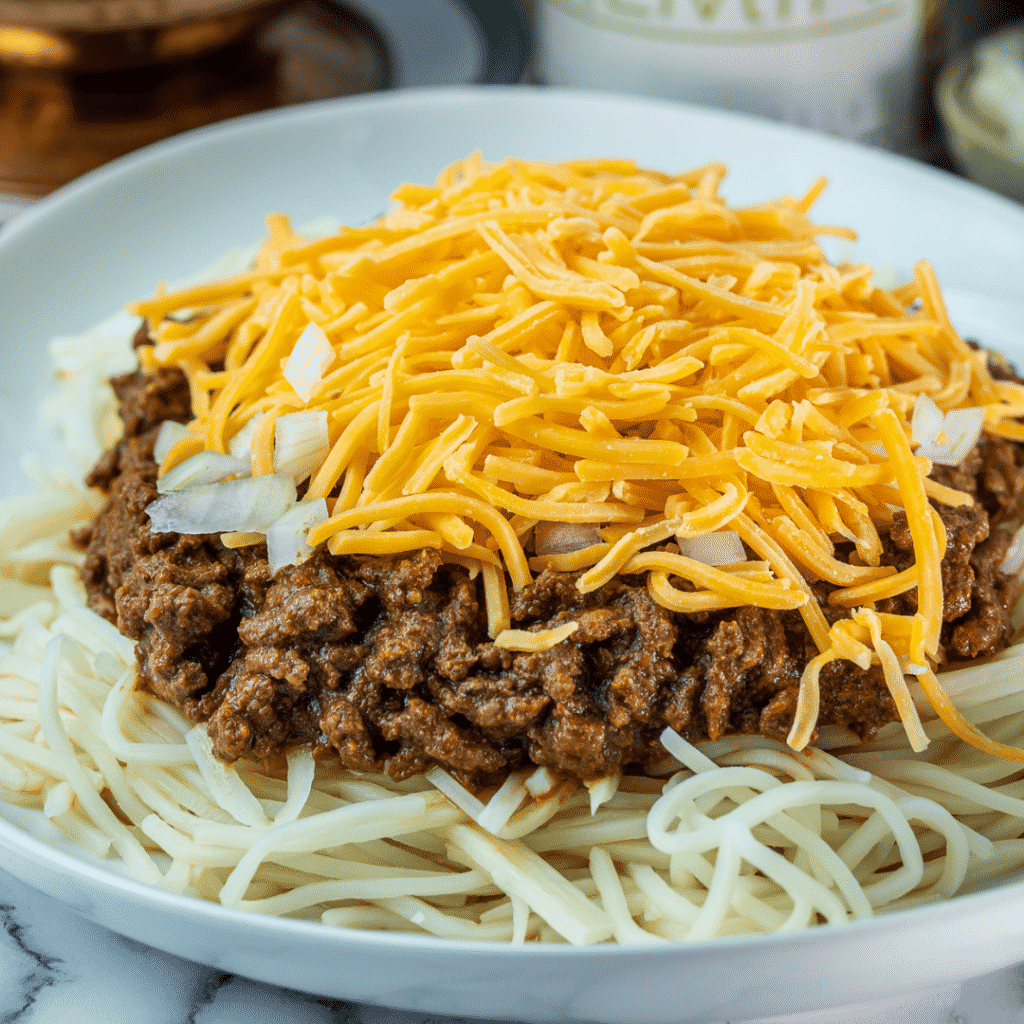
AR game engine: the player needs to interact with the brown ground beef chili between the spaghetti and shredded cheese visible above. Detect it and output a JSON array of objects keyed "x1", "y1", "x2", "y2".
[{"x1": 74, "y1": 371, "x2": 1024, "y2": 787}]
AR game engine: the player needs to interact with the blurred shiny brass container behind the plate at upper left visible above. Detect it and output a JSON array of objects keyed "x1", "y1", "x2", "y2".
[{"x1": 0, "y1": 0, "x2": 289, "y2": 196}]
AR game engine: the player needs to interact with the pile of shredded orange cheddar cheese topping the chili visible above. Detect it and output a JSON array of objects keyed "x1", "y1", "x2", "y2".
[{"x1": 132, "y1": 156, "x2": 1024, "y2": 756}]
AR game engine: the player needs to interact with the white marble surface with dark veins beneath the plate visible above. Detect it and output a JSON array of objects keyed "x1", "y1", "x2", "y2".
[{"x1": 0, "y1": 870, "x2": 1024, "y2": 1024}]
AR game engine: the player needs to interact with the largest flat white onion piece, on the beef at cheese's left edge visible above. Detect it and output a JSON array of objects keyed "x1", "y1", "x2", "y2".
[{"x1": 146, "y1": 473, "x2": 295, "y2": 534}]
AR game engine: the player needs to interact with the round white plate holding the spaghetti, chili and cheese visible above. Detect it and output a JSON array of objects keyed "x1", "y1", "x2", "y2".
[{"x1": 0, "y1": 88, "x2": 1024, "y2": 1024}]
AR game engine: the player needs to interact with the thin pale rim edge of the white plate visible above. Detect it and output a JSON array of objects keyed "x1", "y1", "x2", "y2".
[{"x1": 0, "y1": 85, "x2": 1024, "y2": 958}]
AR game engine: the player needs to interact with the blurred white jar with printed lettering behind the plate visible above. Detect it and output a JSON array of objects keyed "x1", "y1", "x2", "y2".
[{"x1": 538, "y1": 0, "x2": 923, "y2": 150}]
